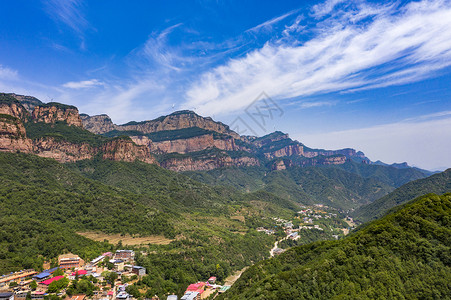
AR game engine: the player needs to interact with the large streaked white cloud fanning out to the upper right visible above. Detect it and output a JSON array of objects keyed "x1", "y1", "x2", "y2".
[{"x1": 185, "y1": 0, "x2": 451, "y2": 114}]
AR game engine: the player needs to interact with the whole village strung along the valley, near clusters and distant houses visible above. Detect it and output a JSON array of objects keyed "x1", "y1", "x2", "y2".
[{"x1": 0, "y1": 205, "x2": 354, "y2": 300}]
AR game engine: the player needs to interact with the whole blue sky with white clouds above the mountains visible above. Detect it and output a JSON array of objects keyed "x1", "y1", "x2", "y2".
[{"x1": 0, "y1": 0, "x2": 451, "y2": 170}]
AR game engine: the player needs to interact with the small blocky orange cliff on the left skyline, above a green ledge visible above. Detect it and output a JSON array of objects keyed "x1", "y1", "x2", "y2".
[{"x1": 32, "y1": 102, "x2": 83, "y2": 127}]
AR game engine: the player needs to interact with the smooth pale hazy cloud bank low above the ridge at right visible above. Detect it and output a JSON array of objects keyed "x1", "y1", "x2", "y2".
[{"x1": 293, "y1": 111, "x2": 451, "y2": 170}]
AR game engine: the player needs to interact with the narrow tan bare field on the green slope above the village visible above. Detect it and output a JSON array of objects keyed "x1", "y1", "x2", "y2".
[{"x1": 77, "y1": 232, "x2": 172, "y2": 246}]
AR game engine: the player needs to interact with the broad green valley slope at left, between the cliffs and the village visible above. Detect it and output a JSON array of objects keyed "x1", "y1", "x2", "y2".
[{"x1": 0, "y1": 153, "x2": 297, "y2": 276}]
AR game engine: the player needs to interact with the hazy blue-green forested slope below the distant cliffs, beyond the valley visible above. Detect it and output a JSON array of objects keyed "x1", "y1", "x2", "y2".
[{"x1": 186, "y1": 166, "x2": 394, "y2": 209}]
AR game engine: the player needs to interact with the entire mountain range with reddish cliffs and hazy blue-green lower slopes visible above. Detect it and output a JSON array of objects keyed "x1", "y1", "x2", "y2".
[{"x1": 0, "y1": 93, "x2": 432, "y2": 210}]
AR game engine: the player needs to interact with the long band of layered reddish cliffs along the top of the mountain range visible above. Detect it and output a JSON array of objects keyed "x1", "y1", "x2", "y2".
[{"x1": 0, "y1": 94, "x2": 369, "y2": 171}]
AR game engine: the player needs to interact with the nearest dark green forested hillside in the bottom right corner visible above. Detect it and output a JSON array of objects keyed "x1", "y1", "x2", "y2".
[{"x1": 222, "y1": 194, "x2": 451, "y2": 300}]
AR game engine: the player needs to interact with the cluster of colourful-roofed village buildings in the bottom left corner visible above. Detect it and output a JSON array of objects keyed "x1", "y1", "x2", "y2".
[{"x1": 0, "y1": 250, "x2": 146, "y2": 300}]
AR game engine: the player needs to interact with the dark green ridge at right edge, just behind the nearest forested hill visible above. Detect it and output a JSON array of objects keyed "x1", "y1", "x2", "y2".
[{"x1": 352, "y1": 169, "x2": 451, "y2": 222}]
